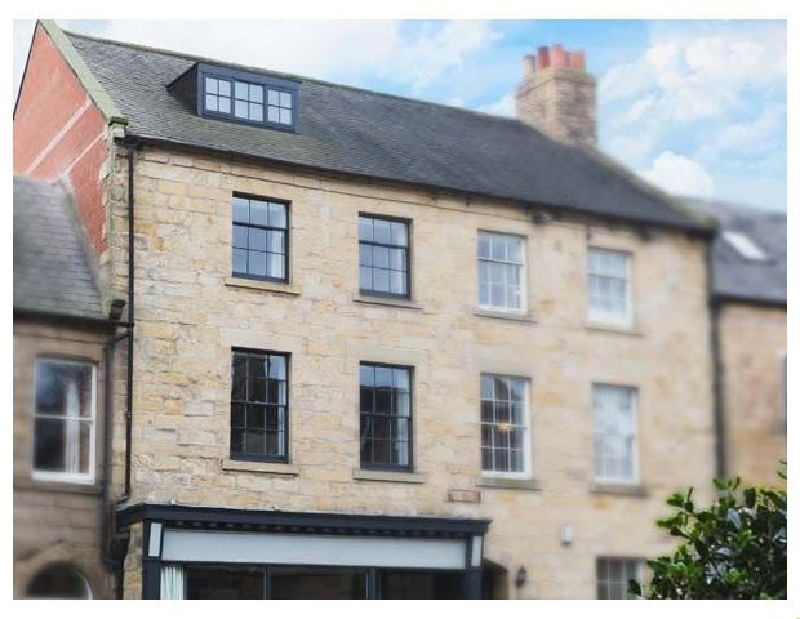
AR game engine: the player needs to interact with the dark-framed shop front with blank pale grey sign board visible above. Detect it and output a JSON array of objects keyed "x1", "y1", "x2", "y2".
[{"x1": 118, "y1": 505, "x2": 489, "y2": 600}]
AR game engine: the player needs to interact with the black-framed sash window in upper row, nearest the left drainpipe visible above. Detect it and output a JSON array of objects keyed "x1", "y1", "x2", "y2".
[{"x1": 231, "y1": 196, "x2": 289, "y2": 282}]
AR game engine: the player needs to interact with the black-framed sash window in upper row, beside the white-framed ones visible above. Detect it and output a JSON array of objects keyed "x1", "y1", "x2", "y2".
[{"x1": 358, "y1": 215, "x2": 411, "y2": 298}]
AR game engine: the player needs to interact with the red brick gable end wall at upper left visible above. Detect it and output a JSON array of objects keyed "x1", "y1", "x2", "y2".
[{"x1": 14, "y1": 26, "x2": 107, "y2": 254}]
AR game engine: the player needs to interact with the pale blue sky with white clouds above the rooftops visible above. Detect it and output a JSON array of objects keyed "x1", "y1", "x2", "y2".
[{"x1": 14, "y1": 20, "x2": 787, "y2": 210}]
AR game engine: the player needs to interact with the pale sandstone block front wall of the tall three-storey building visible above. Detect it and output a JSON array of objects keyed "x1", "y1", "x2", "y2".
[{"x1": 106, "y1": 146, "x2": 714, "y2": 598}]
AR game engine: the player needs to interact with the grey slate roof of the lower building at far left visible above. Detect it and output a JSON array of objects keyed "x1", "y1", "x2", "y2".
[{"x1": 14, "y1": 176, "x2": 104, "y2": 318}]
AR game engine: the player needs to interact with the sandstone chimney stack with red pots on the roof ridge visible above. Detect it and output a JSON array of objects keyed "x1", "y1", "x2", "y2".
[{"x1": 516, "y1": 44, "x2": 597, "y2": 148}]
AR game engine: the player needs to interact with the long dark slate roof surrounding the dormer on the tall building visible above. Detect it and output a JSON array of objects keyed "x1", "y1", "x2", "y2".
[{"x1": 65, "y1": 28, "x2": 708, "y2": 231}]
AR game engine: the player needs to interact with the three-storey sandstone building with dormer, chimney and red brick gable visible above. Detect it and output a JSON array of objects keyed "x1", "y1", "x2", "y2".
[{"x1": 14, "y1": 21, "x2": 714, "y2": 599}]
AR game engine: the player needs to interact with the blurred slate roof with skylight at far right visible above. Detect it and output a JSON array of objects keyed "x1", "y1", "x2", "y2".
[{"x1": 685, "y1": 198, "x2": 786, "y2": 304}]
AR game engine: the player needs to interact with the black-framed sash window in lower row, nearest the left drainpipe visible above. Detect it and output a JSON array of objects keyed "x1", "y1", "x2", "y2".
[{"x1": 231, "y1": 349, "x2": 289, "y2": 461}]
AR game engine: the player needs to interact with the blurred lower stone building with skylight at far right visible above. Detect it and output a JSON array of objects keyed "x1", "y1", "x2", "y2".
[{"x1": 687, "y1": 199, "x2": 787, "y2": 485}]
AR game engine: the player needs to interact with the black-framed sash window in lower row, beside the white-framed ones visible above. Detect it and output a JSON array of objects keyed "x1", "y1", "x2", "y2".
[{"x1": 360, "y1": 363, "x2": 413, "y2": 470}]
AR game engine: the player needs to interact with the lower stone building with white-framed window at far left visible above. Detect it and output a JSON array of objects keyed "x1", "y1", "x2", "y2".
[{"x1": 13, "y1": 177, "x2": 129, "y2": 598}]
